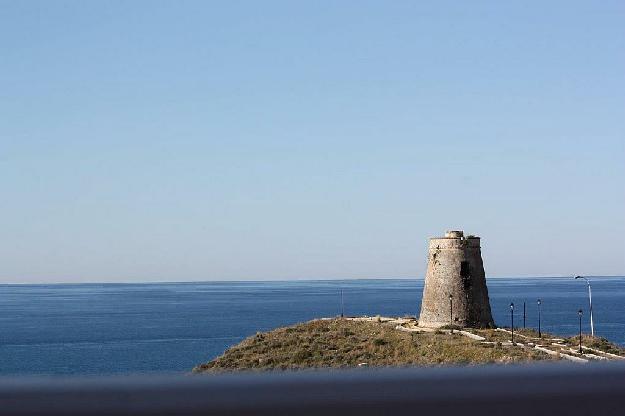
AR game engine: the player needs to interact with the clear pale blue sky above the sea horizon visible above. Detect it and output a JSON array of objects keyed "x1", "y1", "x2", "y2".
[{"x1": 0, "y1": 0, "x2": 625, "y2": 282}]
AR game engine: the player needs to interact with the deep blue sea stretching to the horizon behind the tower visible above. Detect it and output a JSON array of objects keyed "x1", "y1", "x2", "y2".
[{"x1": 0, "y1": 277, "x2": 625, "y2": 375}]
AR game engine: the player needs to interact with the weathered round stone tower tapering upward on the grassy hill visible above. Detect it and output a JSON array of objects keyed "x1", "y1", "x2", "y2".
[{"x1": 419, "y1": 231, "x2": 495, "y2": 328}]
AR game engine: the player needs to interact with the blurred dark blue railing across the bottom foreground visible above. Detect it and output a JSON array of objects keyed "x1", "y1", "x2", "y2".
[{"x1": 0, "y1": 363, "x2": 625, "y2": 416}]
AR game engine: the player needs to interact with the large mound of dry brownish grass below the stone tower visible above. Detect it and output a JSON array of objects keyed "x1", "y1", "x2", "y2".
[{"x1": 194, "y1": 319, "x2": 552, "y2": 372}]
